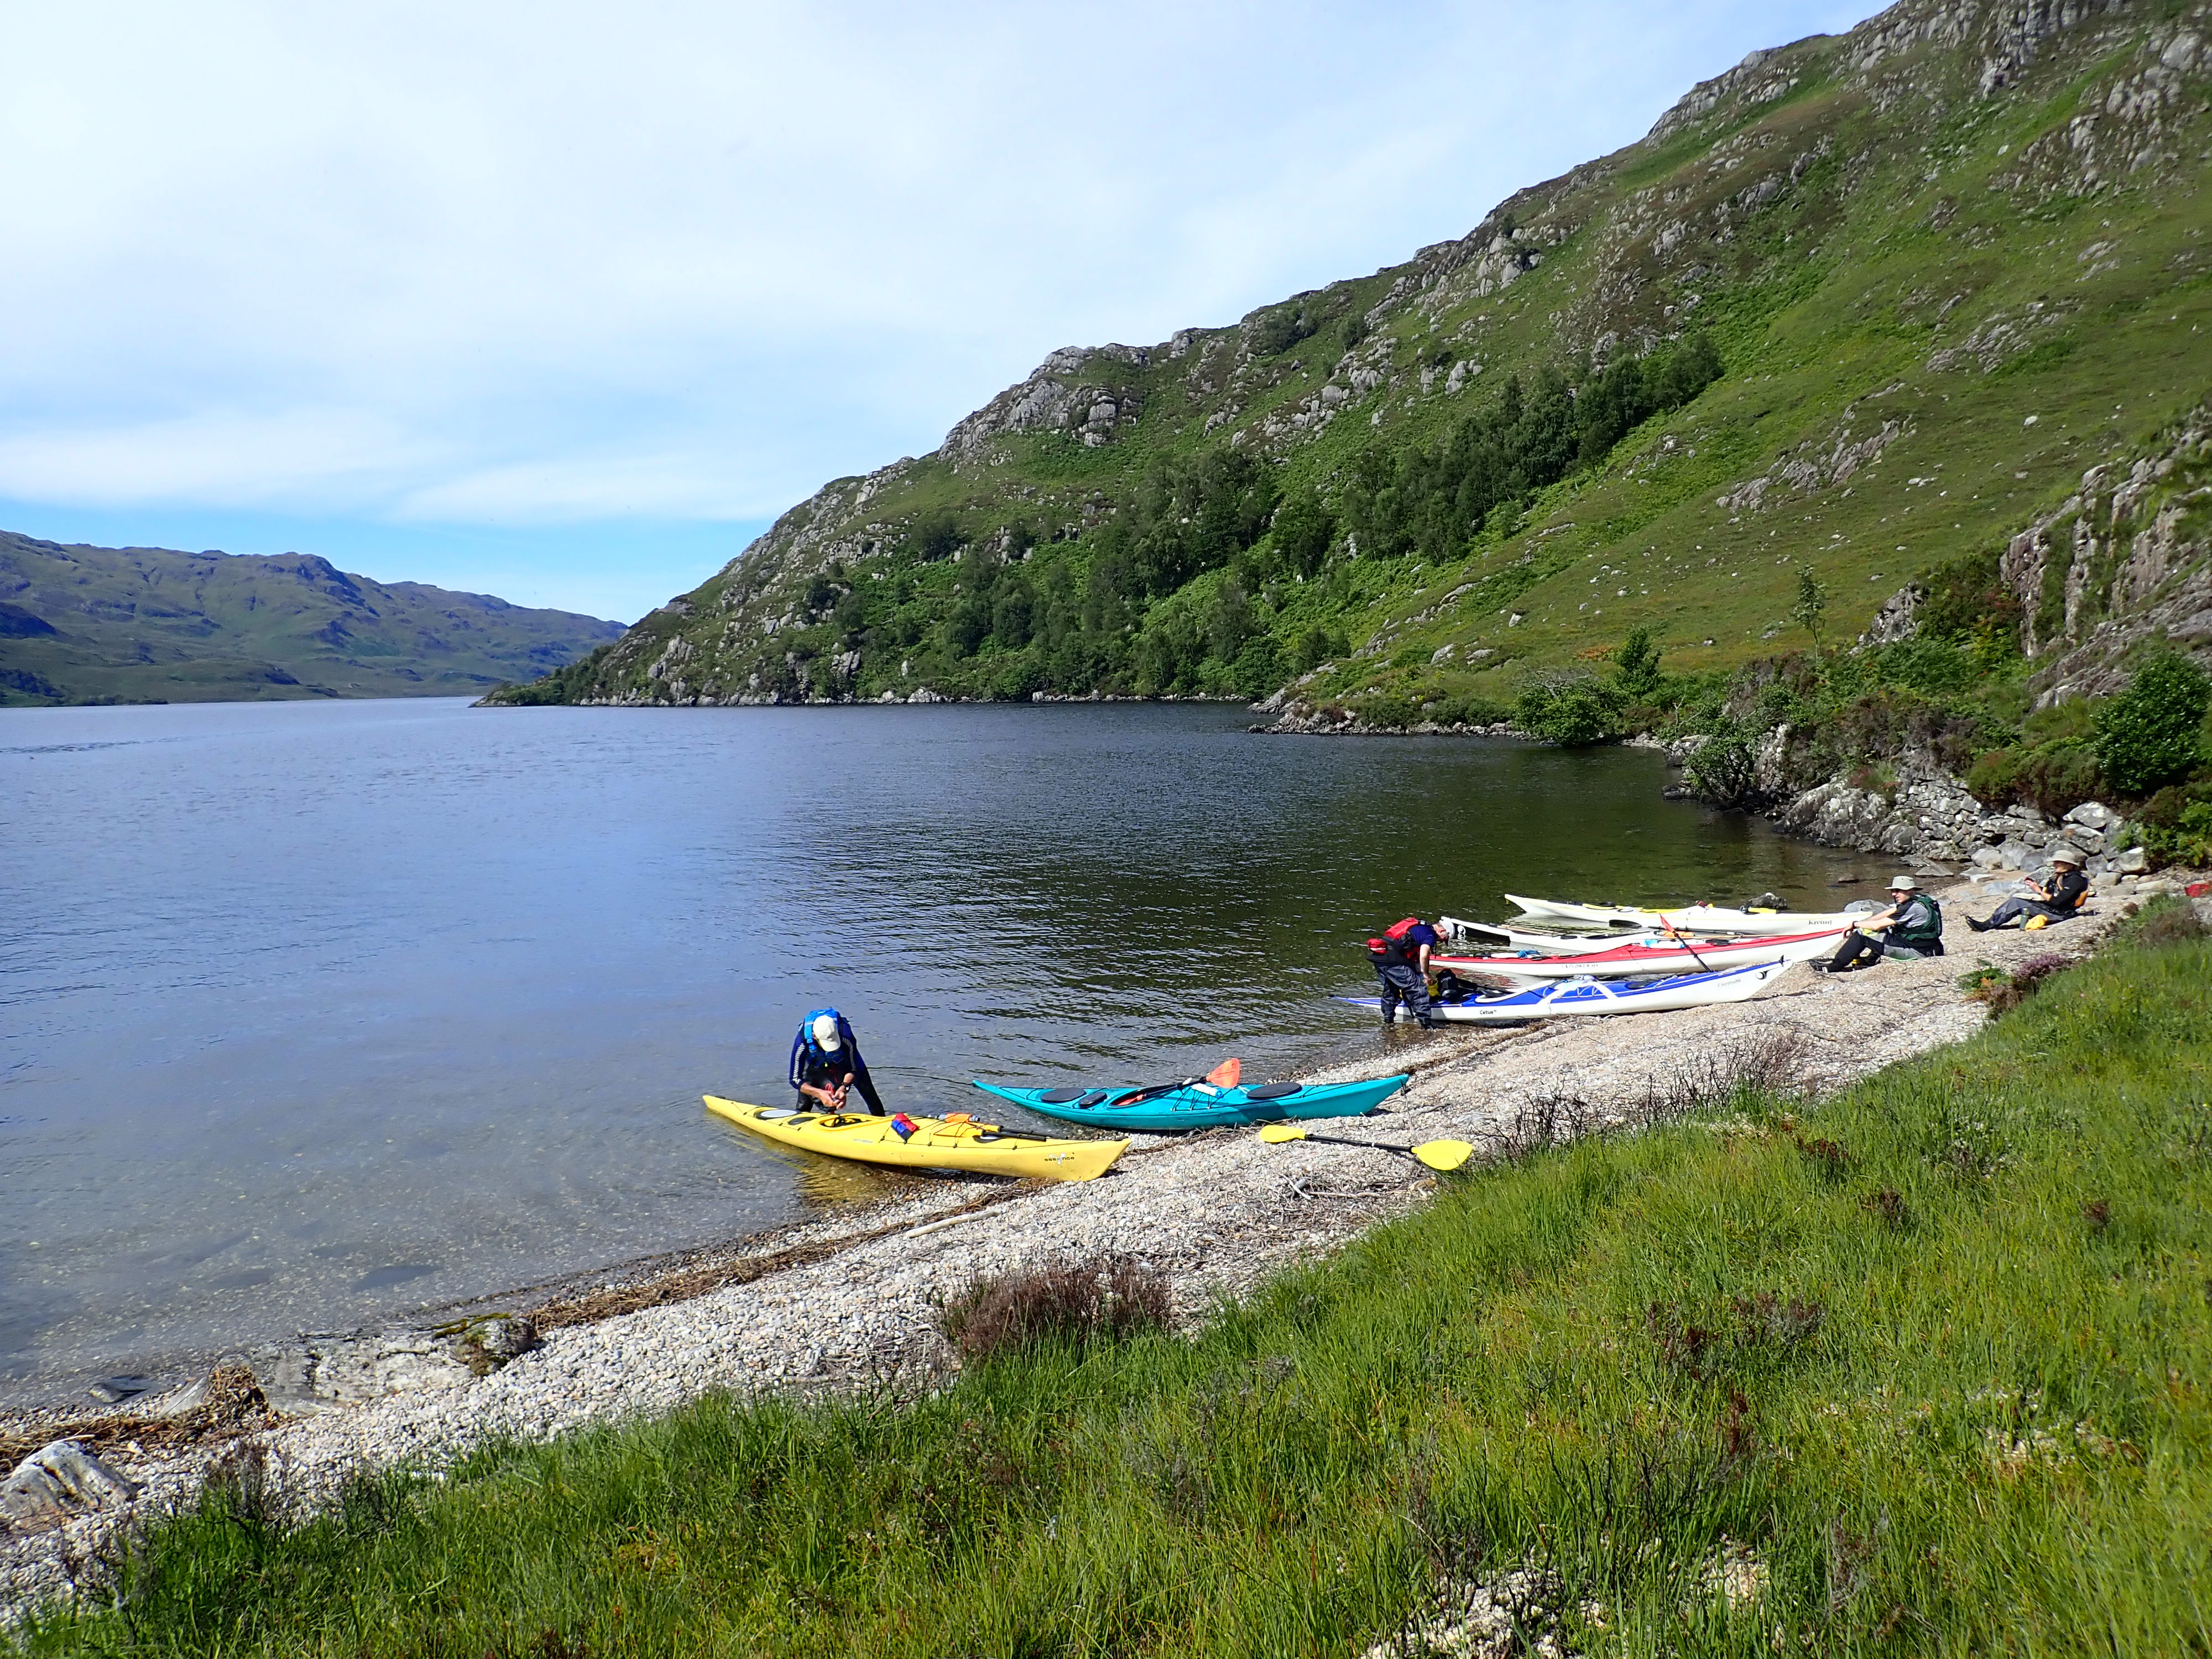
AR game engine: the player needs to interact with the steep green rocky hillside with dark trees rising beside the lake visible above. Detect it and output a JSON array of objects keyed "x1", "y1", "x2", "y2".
[{"x1": 498, "y1": 0, "x2": 2212, "y2": 723}]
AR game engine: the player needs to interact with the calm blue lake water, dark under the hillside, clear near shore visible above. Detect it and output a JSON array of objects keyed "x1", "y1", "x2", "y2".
[{"x1": 0, "y1": 701, "x2": 1865, "y2": 1394}]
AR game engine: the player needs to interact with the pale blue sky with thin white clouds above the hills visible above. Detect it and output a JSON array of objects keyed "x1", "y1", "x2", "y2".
[{"x1": 0, "y1": 0, "x2": 1878, "y2": 622}]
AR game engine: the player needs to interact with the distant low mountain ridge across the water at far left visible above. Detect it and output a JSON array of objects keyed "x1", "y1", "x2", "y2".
[{"x1": 0, "y1": 531, "x2": 622, "y2": 706}]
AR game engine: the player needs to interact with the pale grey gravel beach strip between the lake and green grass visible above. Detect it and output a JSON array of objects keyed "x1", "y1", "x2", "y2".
[{"x1": 0, "y1": 889, "x2": 2159, "y2": 1617}]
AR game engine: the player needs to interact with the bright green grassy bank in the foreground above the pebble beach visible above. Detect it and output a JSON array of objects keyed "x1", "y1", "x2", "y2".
[{"x1": 20, "y1": 940, "x2": 2212, "y2": 1659}]
